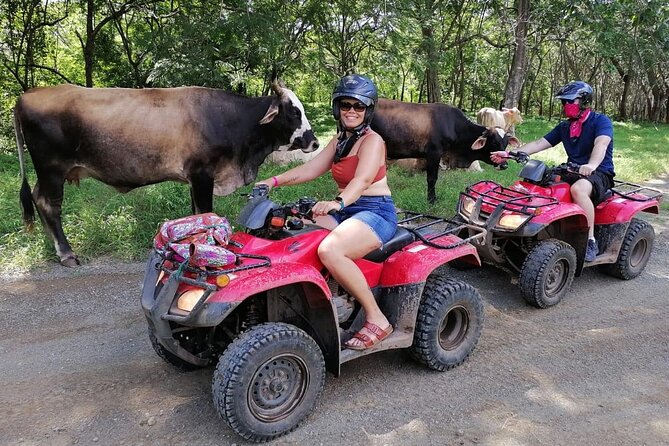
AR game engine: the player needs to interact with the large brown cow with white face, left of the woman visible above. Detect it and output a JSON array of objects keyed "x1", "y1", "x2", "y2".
[{"x1": 14, "y1": 85, "x2": 318, "y2": 266}]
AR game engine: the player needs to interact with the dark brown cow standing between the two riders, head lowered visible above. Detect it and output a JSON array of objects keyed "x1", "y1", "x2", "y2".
[{"x1": 371, "y1": 99, "x2": 518, "y2": 203}]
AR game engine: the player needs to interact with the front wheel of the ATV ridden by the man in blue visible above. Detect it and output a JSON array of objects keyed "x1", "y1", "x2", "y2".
[{"x1": 518, "y1": 239, "x2": 576, "y2": 308}]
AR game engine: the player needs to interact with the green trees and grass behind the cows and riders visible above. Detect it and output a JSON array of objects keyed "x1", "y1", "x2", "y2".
[{"x1": 0, "y1": 0, "x2": 669, "y2": 270}]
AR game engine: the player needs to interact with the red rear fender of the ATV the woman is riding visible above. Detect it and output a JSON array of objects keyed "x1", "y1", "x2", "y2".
[{"x1": 379, "y1": 242, "x2": 481, "y2": 287}]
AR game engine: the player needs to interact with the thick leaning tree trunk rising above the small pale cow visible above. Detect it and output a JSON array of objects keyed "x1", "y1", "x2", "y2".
[{"x1": 504, "y1": 0, "x2": 530, "y2": 108}]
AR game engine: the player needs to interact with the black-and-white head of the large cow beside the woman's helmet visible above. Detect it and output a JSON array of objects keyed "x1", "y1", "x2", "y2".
[{"x1": 260, "y1": 83, "x2": 318, "y2": 153}]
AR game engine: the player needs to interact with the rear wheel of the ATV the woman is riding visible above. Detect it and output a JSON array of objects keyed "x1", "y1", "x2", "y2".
[{"x1": 411, "y1": 276, "x2": 484, "y2": 371}]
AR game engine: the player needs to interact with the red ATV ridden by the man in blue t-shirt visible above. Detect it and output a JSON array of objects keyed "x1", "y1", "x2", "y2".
[{"x1": 457, "y1": 152, "x2": 662, "y2": 308}]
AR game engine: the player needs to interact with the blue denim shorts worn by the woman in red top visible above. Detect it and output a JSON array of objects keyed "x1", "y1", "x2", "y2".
[{"x1": 333, "y1": 195, "x2": 397, "y2": 243}]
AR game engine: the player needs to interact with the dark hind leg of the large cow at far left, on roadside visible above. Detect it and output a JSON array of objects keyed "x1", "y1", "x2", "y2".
[{"x1": 33, "y1": 174, "x2": 79, "y2": 267}]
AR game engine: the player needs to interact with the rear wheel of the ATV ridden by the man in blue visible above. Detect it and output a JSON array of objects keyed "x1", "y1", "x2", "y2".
[{"x1": 604, "y1": 218, "x2": 655, "y2": 280}]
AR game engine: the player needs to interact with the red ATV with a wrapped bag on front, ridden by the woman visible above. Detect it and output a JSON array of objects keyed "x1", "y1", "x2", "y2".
[{"x1": 141, "y1": 188, "x2": 484, "y2": 441}]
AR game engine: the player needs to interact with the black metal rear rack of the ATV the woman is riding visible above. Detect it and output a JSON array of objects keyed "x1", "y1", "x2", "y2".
[{"x1": 397, "y1": 211, "x2": 486, "y2": 249}]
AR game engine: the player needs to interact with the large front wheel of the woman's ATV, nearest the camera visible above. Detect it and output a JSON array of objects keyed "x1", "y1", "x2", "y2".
[{"x1": 212, "y1": 322, "x2": 325, "y2": 442}]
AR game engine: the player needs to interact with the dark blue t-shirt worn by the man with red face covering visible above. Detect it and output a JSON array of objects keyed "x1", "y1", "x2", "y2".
[{"x1": 544, "y1": 110, "x2": 615, "y2": 176}]
